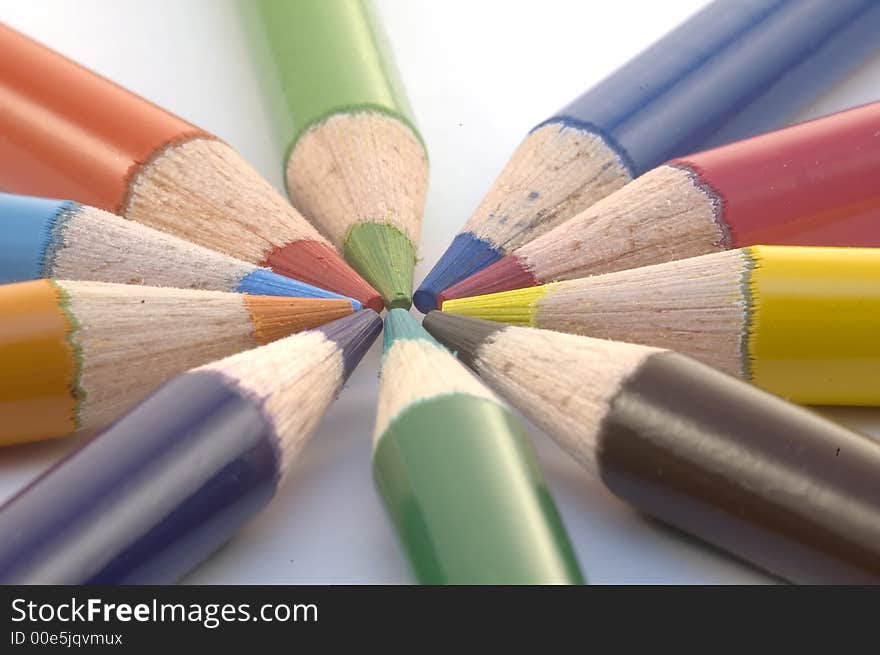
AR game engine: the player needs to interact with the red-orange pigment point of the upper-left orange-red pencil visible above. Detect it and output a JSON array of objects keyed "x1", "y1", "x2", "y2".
[{"x1": 265, "y1": 239, "x2": 383, "y2": 312}]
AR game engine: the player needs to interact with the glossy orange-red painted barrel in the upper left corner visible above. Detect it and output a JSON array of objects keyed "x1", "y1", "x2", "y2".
[{"x1": 0, "y1": 25, "x2": 209, "y2": 213}]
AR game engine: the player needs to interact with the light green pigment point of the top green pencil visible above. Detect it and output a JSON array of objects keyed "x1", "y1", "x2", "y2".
[{"x1": 343, "y1": 222, "x2": 416, "y2": 309}]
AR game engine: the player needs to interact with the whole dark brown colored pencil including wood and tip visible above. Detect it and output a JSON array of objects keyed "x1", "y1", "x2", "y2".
[{"x1": 425, "y1": 312, "x2": 880, "y2": 584}]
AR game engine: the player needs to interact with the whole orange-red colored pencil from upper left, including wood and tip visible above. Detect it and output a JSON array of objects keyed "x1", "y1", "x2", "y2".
[{"x1": 0, "y1": 25, "x2": 381, "y2": 309}]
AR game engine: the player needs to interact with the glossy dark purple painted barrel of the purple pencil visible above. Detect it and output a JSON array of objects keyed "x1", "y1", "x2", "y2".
[{"x1": 0, "y1": 373, "x2": 278, "y2": 584}]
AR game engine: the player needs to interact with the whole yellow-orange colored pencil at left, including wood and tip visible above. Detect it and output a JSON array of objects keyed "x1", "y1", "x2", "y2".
[{"x1": 0, "y1": 280, "x2": 353, "y2": 445}]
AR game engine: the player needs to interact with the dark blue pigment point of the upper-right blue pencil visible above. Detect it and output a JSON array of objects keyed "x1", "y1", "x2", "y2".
[{"x1": 413, "y1": 232, "x2": 504, "y2": 314}]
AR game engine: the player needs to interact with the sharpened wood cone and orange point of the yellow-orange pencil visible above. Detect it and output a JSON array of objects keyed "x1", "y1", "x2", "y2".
[{"x1": 41, "y1": 280, "x2": 352, "y2": 427}]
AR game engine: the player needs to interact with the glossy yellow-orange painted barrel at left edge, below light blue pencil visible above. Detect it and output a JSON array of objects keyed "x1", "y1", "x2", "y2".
[{"x1": 0, "y1": 280, "x2": 79, "y2": 446}]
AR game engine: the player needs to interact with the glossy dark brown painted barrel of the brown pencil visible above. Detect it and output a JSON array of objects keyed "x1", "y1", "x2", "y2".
[{"x1": 597, "y1": 352, "x2": 880, "y2": 584}]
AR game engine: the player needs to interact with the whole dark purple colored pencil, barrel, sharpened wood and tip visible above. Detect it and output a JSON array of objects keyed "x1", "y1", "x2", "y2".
[{"x1": 0, "y1": 310, "x2": 382, "y2": 584}]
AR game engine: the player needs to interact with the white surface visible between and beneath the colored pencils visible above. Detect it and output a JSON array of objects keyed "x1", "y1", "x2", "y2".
[{"x1": 0, "y1": 0, "x2": 880, "y2": 583}]
